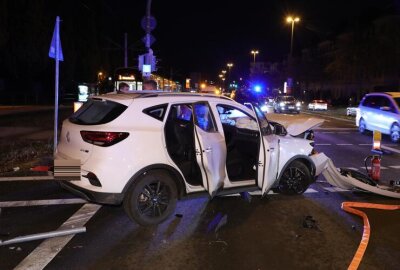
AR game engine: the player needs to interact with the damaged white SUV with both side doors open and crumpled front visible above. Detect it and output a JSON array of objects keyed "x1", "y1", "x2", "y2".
[{"x1": 56, "y1": 91, "x2": 322, "y2": 225}]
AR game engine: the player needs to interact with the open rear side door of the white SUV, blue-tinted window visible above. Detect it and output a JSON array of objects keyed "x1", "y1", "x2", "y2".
[{"x1": 193, "y1": 102, "x2": 226, "y2": 197}]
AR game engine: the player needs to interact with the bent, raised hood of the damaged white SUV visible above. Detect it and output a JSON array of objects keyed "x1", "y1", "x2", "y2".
[{"x1": 268, "y1": 114, "x2": 324, "y2": 136}]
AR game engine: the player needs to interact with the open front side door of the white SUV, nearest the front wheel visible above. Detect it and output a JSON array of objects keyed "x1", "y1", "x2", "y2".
[{"x1": 245, "y1": 103, "x2": 279, "y2": 195}]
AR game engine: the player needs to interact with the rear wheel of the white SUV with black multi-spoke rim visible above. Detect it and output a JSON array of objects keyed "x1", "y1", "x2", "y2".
[{"x1": 124, "y1": 171, "x2": 178, "y2": 226}]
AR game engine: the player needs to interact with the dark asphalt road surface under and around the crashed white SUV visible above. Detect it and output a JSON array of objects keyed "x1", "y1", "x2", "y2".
[{"x1": 0, "y1": 108, "x2": 400, "y2": 269}]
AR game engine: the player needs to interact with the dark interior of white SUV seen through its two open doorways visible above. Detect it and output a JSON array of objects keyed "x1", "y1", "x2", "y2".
[{"x1": 164, "y1": 104, "x2": 260, "y2": 188}]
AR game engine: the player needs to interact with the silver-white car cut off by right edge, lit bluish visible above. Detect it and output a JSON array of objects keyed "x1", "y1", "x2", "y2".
[{"x1": 356, "y1": 92, "x2": 400, "y2": 143}]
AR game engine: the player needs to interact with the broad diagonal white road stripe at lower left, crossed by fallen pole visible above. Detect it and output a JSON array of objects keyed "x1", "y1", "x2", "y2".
[{"x1": 14, "y1": 204, "x2": 101, "y2": 270}]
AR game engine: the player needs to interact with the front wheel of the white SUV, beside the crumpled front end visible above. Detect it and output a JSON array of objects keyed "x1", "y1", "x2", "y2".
[{"x1": 278, "y1": 160, "x2": 312, "y2": 195}]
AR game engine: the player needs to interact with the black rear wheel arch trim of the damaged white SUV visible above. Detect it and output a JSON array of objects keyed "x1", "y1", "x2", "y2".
[{"x1": 122, "y1": 163, "x2": 185, "y2": 199}]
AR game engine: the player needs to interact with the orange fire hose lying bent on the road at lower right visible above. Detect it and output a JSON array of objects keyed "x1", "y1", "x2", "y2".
[{"x1": 342, "y1": 202, "x2": 400, "y2": 270}]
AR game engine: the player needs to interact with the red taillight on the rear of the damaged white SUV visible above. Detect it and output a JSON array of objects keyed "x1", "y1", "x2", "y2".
[{"x1": 81, "y1": 130, "x2": 129, "y2": 146}]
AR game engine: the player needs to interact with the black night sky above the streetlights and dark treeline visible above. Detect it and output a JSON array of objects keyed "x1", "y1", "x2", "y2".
[{"x1": 0, "y1": 0, "x2": 400, "y2": 84}]
